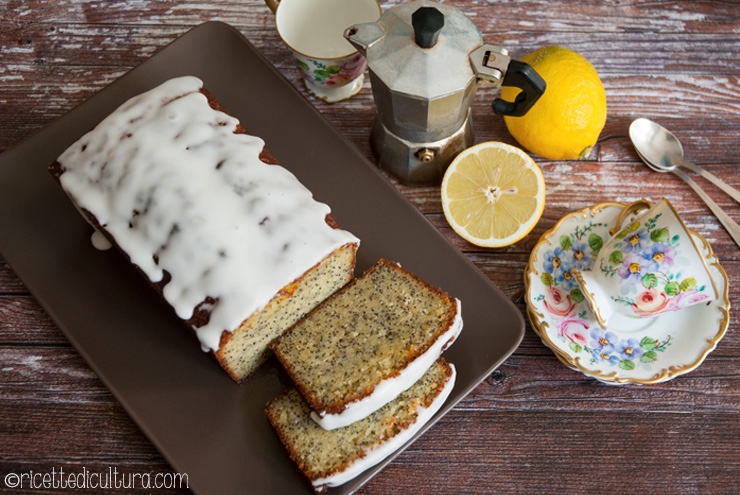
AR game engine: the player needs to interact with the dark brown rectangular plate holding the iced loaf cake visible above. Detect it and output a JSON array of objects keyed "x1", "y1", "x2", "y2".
[{"x1": 0, "y1": 22, "x2": 524, "y2": 495}]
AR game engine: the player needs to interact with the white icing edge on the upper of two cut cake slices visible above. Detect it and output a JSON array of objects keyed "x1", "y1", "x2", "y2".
[{"x1": 311, "y1": 299, "x2": 463, "y2": 430}]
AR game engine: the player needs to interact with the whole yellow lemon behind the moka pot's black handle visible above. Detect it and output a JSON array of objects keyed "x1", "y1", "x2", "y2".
[{"x1": 501, "y1": 46, "x2": 606, "y2": 160}]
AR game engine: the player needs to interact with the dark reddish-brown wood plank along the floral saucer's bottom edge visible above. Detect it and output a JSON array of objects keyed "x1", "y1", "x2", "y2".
[{"x1": 457, "y1": 354, "x2": 740, "y2": 414}]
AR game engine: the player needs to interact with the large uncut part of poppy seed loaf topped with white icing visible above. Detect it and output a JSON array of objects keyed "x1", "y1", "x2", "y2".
[{"x1": 50, "y1": 76, "x2": 359, "y2": 381}]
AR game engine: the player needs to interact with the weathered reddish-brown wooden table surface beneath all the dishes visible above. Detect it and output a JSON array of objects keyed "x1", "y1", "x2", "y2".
[{"x1": 0, "y1": 0, "x2": 740, "y2": 495}]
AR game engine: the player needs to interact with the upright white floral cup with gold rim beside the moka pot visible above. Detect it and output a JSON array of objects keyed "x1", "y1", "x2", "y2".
[{"x1": 265, "y1": 0, "x2": 382, "y2": 103}]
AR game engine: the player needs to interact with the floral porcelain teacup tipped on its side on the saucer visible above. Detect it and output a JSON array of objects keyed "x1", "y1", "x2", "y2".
[{"x1": 573, "y1": 199, "x2": 718, "y2": 328}]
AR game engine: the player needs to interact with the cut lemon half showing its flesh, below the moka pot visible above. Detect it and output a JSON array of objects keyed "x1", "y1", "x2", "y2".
[{"x1": 441, "y1": 141, "x2": 545, "y2": 247}]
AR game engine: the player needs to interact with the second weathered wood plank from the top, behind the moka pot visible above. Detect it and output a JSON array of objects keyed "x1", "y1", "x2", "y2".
[{"x1": 2, "y1": 22, "x2": 740, "y2": 73}]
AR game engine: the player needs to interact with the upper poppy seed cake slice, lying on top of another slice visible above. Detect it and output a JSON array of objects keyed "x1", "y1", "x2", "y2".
[{"x1": 271, "y1": 260, "x2": 462, "y2": 429}]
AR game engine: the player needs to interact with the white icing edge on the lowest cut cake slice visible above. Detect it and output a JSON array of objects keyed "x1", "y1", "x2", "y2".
[{"x1": 312, "y1": 364, "x2": 457, "y2": 487}]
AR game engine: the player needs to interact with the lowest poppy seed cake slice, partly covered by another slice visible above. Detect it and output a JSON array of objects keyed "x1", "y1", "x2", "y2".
[{"x1": 265, "y1": 358, "x2": 456, "y2": 493}]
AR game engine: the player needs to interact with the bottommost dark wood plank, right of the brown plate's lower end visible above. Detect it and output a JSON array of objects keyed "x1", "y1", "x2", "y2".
[{"x1": 361, "y1": 410, "x2": 740, "y2": 495}]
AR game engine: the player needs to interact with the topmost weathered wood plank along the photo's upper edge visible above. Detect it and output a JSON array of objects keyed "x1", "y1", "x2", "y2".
[{"x1": 0, "y1": 0, "x2": 738, "y2": 34}]
